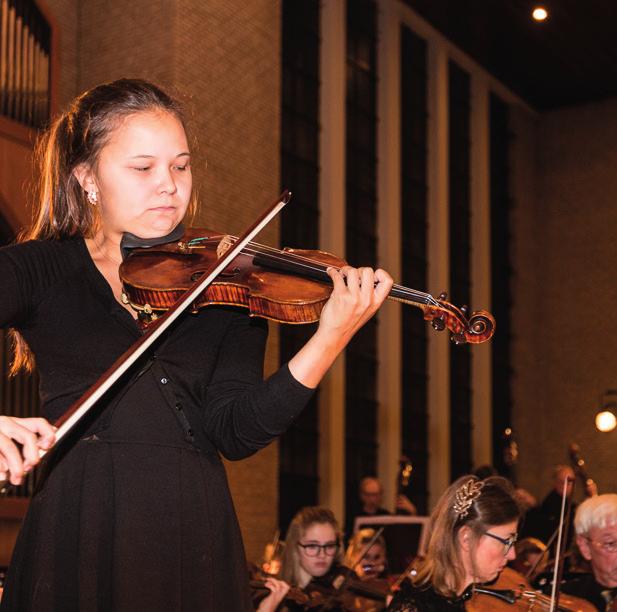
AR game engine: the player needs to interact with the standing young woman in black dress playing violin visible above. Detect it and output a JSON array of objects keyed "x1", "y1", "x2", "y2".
[{"x1": 0, "y1": 79, "x2": 392, "y2": 612}]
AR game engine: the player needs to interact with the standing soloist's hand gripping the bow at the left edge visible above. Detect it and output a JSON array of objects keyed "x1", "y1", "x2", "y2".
[{"x1": 0, "y1": 416, "x2": 56, "y2": 485}]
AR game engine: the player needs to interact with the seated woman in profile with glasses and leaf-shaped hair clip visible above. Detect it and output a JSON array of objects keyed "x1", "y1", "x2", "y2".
[{"x1": 388, "y1": 476, "x2": 520, "y2": 612}]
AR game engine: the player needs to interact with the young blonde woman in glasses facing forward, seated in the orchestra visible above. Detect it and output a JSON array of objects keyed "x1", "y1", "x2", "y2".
[{"x1": 257, "y1": 506, "x2": 343, "y2": 612}]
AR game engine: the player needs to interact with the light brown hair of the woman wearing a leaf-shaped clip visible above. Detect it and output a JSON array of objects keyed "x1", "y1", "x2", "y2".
[{"x1": 413, "y1": 475, "x2": 521, "y2": 597}]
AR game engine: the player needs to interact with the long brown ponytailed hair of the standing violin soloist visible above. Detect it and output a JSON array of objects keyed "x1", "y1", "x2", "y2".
[{"x1": 10, "y1": 79, "x2": 195, "y2": 375}]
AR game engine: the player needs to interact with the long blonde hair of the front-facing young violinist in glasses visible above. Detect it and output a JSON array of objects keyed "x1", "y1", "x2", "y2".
[{"x1": 279, "y1": 506, "x2": 343, "y2": 586}]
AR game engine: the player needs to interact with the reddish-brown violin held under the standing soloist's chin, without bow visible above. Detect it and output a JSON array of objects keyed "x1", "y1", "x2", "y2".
[{"x1": 120, "y1": 228, "x2": 495, "y2": 344}]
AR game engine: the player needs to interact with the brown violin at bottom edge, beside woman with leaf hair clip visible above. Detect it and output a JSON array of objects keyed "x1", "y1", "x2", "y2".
[{"x1": 465, "y1": 567, "x2": 596, "y2": 612}]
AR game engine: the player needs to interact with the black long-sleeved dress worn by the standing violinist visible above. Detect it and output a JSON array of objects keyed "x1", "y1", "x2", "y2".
[{"x1": 0, "y1": 238, "x2": 311, "y2": 612}]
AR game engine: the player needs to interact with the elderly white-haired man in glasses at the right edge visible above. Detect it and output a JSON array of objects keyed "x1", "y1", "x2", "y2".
[{"x1": 561, "y1": 493, "x2": 617, "y2": 612}]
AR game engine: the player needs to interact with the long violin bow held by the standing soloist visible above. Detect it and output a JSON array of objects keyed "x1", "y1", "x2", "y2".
[{"x1": 0, "y1": 190, "x2": 291, "y2": 495}]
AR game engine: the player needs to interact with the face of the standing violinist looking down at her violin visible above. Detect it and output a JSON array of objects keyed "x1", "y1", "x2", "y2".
[{"x1": 85, "y1": 110, "x2": 192, "y2": 238}]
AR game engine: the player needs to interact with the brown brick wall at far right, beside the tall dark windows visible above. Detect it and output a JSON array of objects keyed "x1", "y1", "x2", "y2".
[{"x1": 514, "y1": 100, "x2": 617, "y2": 496}]
